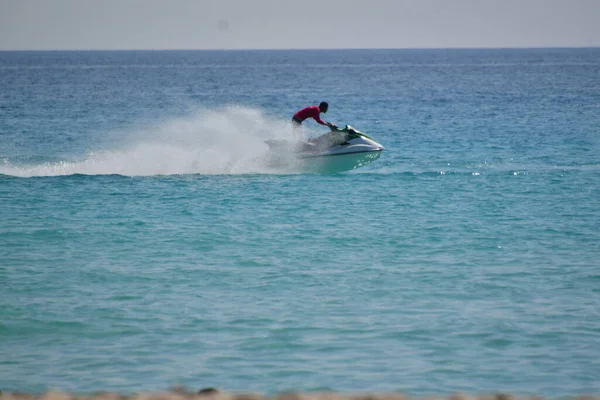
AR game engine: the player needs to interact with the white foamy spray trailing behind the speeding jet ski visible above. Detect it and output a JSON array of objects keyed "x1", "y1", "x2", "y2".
[{"x1": 0, "y1": 106, "x2": 300, "y2": 177}]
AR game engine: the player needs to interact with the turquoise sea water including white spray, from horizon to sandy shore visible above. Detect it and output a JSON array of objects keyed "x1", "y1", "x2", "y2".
[{"x1": 0, "y1": 49, "x2": 600, "y2": 398}]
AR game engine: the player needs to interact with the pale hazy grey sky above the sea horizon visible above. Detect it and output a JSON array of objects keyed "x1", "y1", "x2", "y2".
[{"x1": 0, "y1": 0, "x2": 600, "y2": 50}]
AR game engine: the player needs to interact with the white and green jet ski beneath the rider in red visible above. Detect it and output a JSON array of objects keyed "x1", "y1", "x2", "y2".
[{"x1": 265, "y1": 125, "x2": 384, "y2": 173}]
